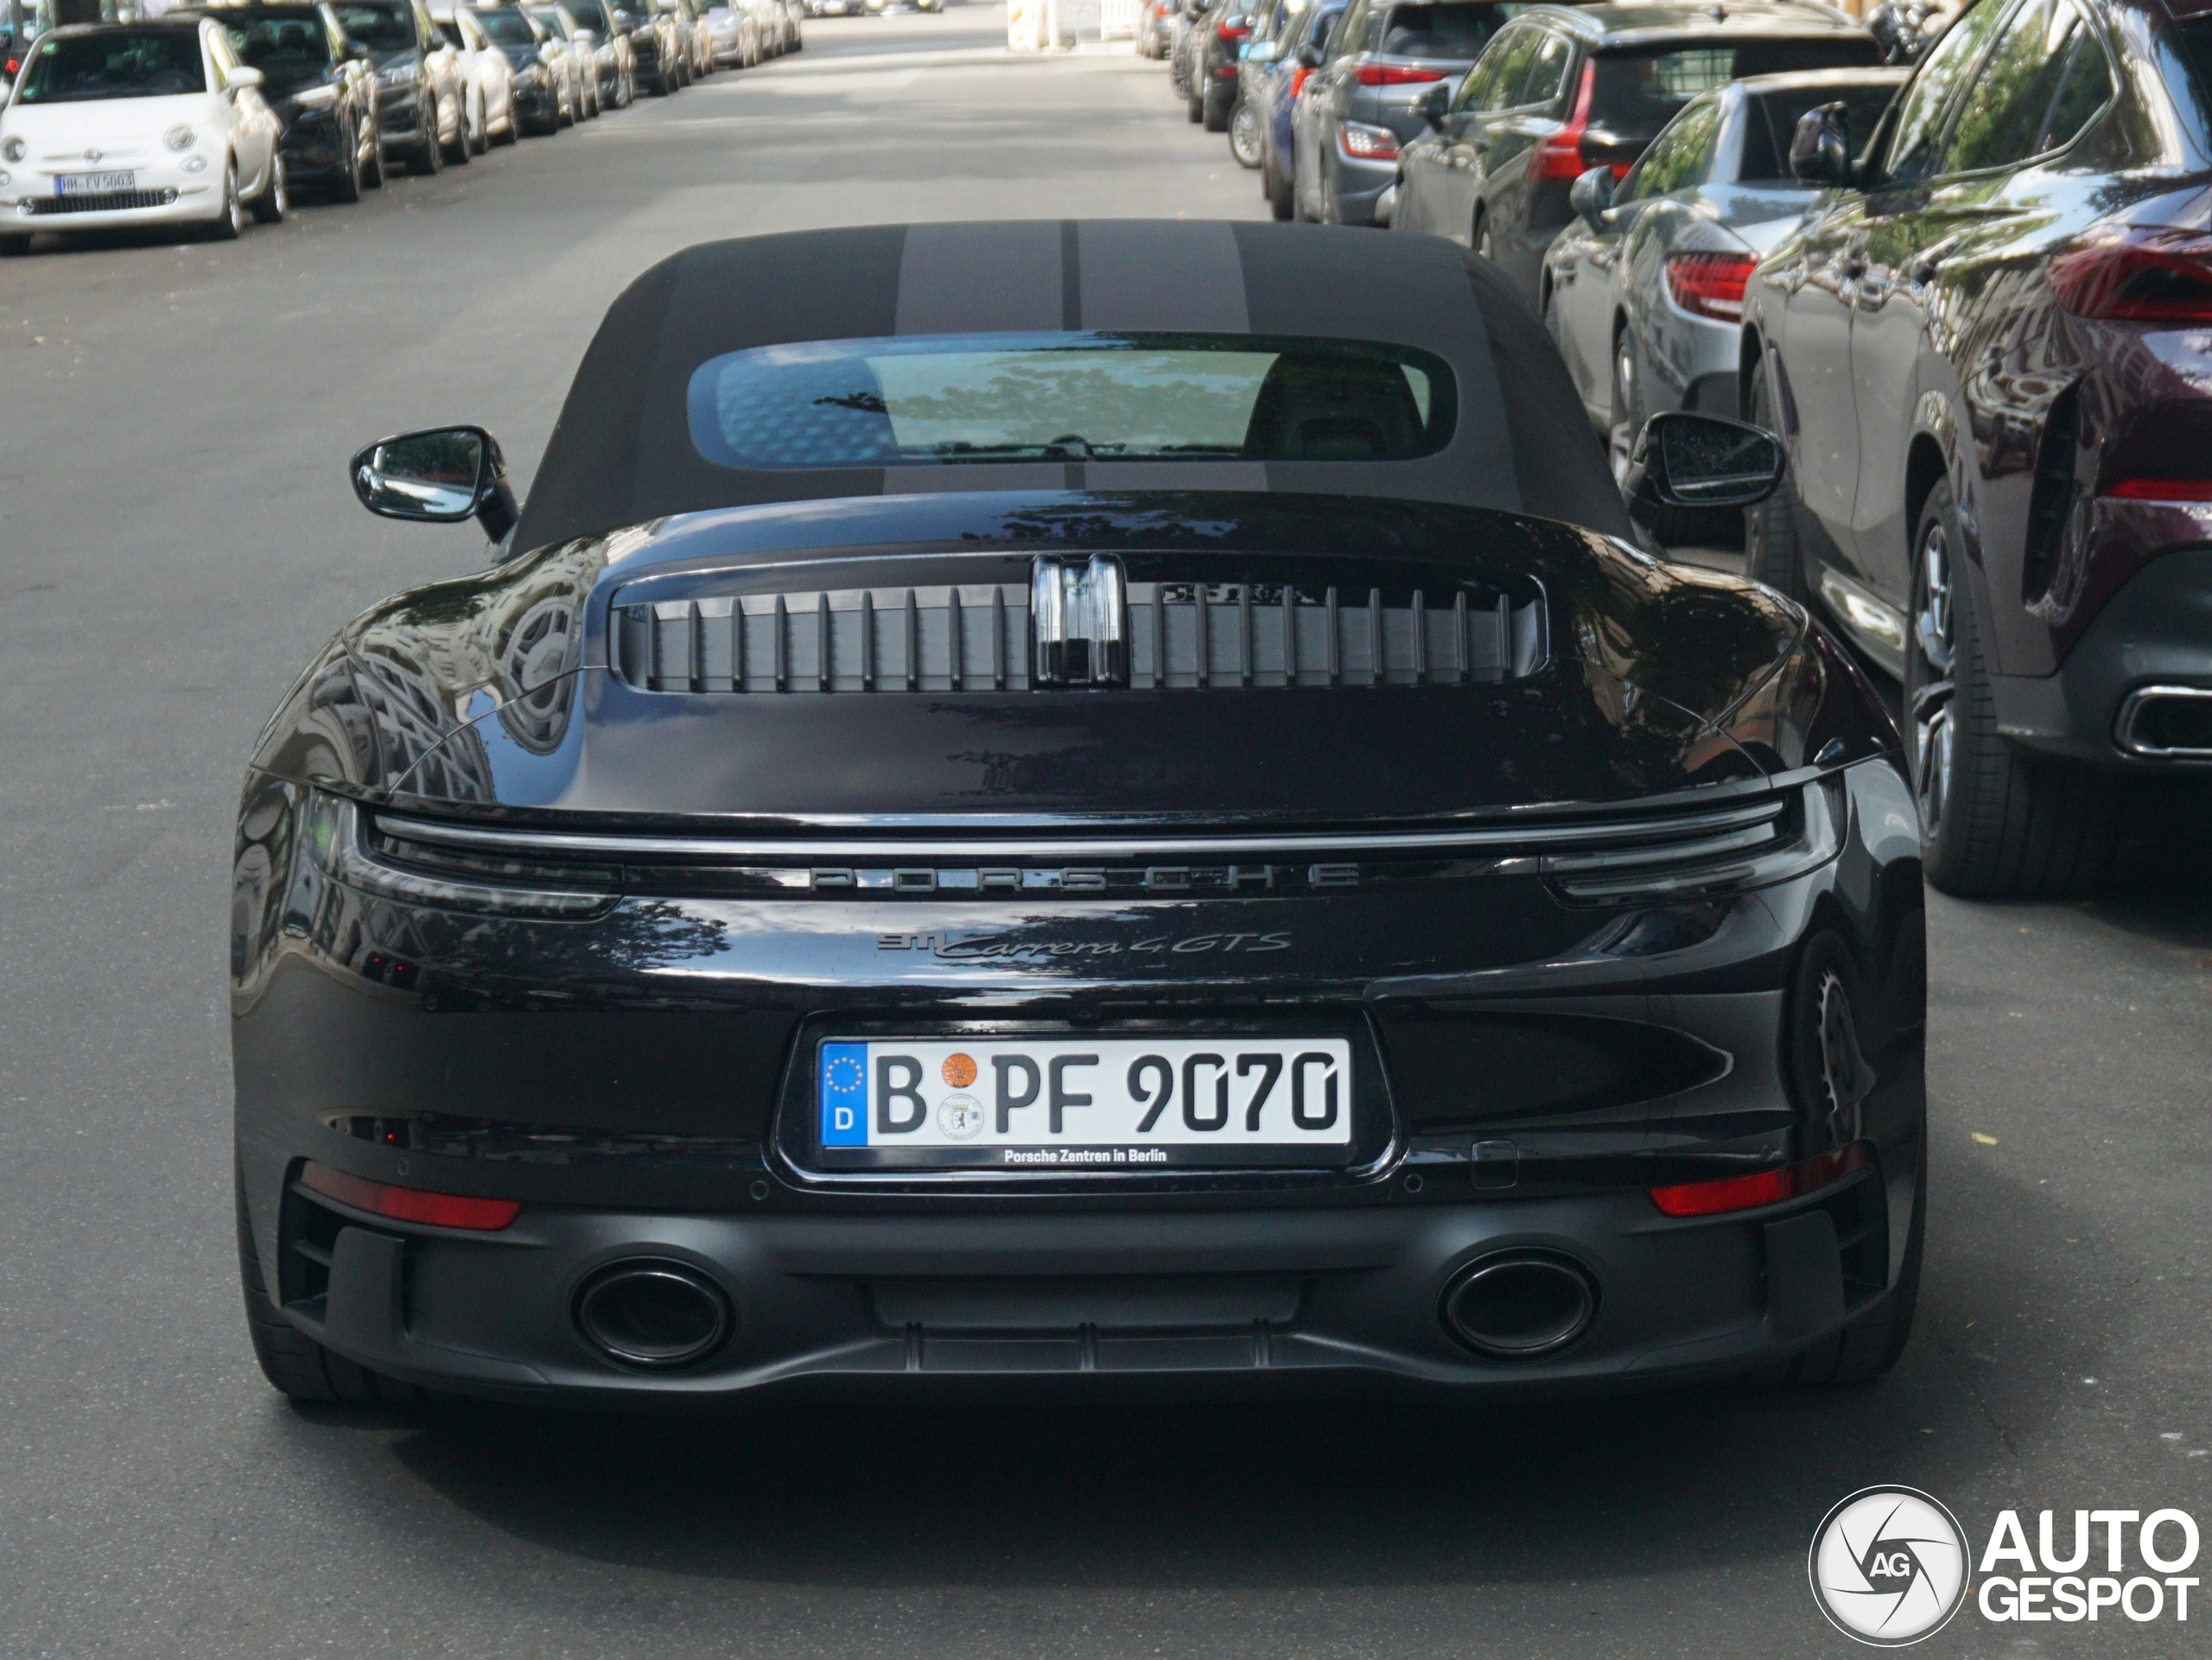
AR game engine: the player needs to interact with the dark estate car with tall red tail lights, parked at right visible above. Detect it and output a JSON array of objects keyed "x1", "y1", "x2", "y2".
[{"x1": 1391, "y1": 0, "x2": 1880, "y2": 305}]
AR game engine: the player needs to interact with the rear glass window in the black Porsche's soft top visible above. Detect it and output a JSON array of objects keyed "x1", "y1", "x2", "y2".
[{"x1": 690, "y1": 332, "x2": 1458, "y2": 469}]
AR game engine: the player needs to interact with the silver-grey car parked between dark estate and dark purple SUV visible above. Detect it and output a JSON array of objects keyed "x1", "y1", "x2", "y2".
[{"x1": 1540, "y1": 68, "x2": 1904, "y2": 478}]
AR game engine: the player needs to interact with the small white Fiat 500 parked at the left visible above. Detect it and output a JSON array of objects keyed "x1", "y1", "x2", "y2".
[{"x1": 0, "y1": 17, "x2": 288, "y2": 255}]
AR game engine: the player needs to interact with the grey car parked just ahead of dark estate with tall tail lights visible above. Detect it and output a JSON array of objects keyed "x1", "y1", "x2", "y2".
[{"x1": 1292, "y1": 0, "x2": 1520, "y2": 226}]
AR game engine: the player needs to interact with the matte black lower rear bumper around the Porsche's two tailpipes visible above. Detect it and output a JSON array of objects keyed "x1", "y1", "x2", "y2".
[{"x1": 264, "y1": 1153, "x2": 1913, "y2": 1405}]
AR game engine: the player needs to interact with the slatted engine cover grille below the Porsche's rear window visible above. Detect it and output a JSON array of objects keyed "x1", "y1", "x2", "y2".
[{"x1": 608, "y1": 582, "x2": 1546, "y2": 693}]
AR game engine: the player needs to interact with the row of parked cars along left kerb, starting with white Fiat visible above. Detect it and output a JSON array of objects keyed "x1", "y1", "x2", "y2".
[{"x1": 0, "y1": 0, "x2": 803, "y2": 255}]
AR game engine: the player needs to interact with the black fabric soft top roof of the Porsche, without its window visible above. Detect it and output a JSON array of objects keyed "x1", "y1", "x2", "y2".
[{"x1": 515, "y1": 219, "x2": 1630, "y2": 549}]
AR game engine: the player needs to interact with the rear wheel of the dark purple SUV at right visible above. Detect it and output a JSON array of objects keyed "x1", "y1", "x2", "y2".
[{"x1": 1904, "y1": 480, "x2": 2126, "y2": 899}]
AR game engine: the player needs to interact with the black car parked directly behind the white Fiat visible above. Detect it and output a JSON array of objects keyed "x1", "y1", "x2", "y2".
[{"x1": 188, "y1": 0, "x2": 385, "y2": 201}]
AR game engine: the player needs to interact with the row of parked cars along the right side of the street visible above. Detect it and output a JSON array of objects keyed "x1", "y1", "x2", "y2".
[{"x1": 1137, "y1": 0, "x2": 2212, "y2": 894}]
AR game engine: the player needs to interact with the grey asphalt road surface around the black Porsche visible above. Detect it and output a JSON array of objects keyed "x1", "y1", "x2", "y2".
[{"x1": 0, "y1": 7, "x2": 2212, "y2": 1660}]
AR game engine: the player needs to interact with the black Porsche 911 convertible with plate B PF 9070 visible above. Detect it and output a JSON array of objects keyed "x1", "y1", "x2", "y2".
[{"x1": 232, "y1": 221, "x2": 1924, "y2": 1403}]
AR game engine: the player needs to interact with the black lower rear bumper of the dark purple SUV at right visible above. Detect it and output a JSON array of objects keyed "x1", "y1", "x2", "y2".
[{"x1": 1991, "y1": 544, "x2": 2212, "y2": 774}]
